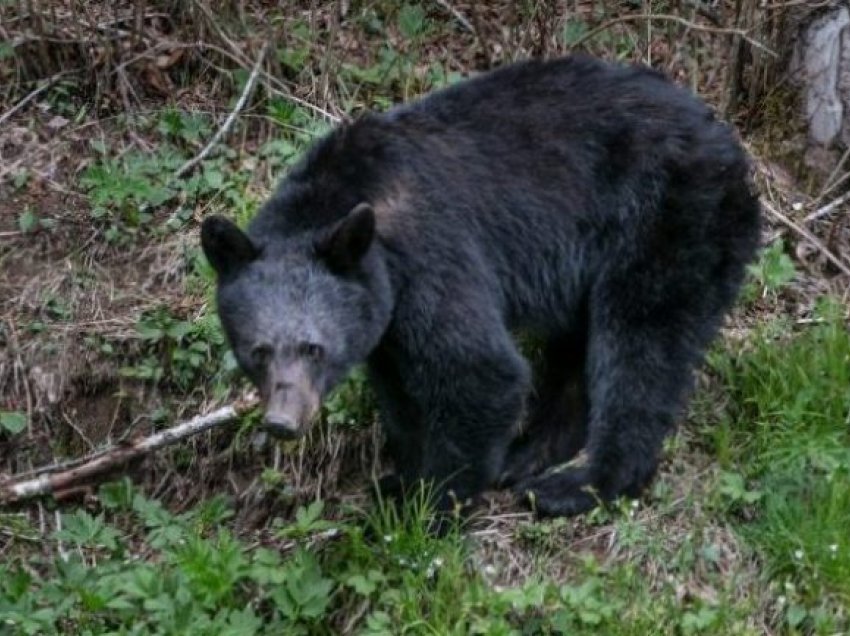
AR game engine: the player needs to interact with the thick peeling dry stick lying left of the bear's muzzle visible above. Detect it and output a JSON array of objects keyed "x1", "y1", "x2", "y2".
[{"x1": 0, "y1": 400, "x2": 256, "y2": 504}]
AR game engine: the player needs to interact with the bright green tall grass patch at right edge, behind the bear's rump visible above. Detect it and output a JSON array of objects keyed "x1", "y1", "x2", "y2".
[{"x1": 714, "y1": 301, "x2": 850, "y2": 630}]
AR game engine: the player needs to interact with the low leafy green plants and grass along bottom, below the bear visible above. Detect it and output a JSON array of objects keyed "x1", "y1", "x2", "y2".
[{"x1": 0, "y1": 481, "x2": 753, "y2": 636}]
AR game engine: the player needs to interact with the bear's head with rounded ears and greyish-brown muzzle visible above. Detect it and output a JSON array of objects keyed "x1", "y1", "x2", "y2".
[{"x1": 201, "y1": 203, "x2": 392, "y2": 437}]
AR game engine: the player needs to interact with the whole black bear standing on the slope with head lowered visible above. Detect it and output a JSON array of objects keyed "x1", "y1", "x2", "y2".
[{"x1": 201, "y1": 57, "x2": 759, "y2": 515}]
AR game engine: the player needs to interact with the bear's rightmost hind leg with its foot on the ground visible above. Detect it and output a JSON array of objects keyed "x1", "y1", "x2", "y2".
[{"x1": 515, "y1": 263, "x2": 727, "y2": 516}]
